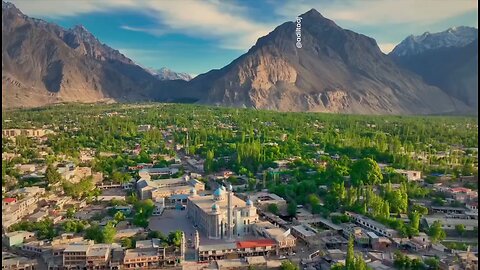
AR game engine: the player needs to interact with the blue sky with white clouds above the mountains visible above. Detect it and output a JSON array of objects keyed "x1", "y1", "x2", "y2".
[{"x1": 7, "y1": 0, "x2": 478, "y2": 76}]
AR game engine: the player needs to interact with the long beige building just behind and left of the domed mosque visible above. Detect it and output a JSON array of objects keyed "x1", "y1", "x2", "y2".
[{"x1": 137, "y1": 175, "x2": 205, "y2": 201}]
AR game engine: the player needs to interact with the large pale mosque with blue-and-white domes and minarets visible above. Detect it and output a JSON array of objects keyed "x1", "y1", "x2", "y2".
[{"x1": 187, "y1": 186, "x2": 258, "y2": 239}]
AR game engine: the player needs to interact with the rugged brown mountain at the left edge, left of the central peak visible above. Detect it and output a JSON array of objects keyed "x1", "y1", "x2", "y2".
[{"x1": 2, "y1": 1, "x2": 159, "y2": 108}]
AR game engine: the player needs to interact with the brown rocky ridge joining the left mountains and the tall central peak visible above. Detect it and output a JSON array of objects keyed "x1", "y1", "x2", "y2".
[{"x1": 2, "y1": 1, "x2": 476, "y2": 114}]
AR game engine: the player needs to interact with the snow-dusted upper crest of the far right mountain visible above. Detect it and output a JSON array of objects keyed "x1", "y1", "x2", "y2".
[{"x1": 390, "y1": 26, "x2": 478, "y2": 57}]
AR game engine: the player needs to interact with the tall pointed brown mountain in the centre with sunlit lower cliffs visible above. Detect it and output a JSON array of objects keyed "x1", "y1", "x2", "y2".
[{"x1": 188, "y1": 9, "x2": 469, "y2": 114}]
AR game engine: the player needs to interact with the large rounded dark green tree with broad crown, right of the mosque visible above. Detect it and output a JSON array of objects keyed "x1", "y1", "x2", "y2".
[{"x1": 350, "y1": 158, "x2": 383, "y2": 186}]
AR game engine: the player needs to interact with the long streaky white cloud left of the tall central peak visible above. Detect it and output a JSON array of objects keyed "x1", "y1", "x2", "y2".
[{"x1": 12, "y1": 0, "x2": 275, "y2": 50}]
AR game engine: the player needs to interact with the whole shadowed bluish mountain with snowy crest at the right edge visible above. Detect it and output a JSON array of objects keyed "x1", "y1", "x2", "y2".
[{"x1": 390, "y1": 26, "x2": 478, "y2": 111}]
